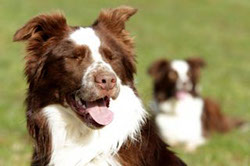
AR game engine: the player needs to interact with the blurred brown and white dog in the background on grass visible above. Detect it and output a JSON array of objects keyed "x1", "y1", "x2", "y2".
[{"x1": 148, "y1": 58, "x2": 242, "y2": 151}]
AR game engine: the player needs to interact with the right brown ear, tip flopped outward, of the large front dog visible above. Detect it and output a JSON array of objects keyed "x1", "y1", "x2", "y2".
[{"x1": 94, "y1": 6, "x2": 137, "y2": 34}]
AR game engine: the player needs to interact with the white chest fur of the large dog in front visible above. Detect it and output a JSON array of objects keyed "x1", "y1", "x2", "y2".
[{"x1": 43, "y1": 86, "x2": 146, "y2": 166}]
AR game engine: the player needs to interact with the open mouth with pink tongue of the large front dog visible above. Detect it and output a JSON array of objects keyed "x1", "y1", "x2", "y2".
[{"x1": 68, "y1": 93, "x2": 113, "y2": 128}]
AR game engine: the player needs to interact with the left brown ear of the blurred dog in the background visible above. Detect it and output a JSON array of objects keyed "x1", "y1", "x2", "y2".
[{"x1": 148, "y1": 59, "x2": 169, "y2": 80}]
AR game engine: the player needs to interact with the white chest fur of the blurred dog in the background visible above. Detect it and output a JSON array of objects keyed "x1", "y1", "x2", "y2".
[{"x1": 156, "y1": 96, "x2": 205, "y2": 150}]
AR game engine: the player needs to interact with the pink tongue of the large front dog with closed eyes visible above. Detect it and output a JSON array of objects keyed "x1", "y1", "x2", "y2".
[{"x1": 86, "y1": 100, "x2": 113, "y2": 125}]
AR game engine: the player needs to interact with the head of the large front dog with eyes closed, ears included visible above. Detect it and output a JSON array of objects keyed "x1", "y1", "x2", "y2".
[{"x1": 14, "y1": 6, "x2": 136, "y2": 128}]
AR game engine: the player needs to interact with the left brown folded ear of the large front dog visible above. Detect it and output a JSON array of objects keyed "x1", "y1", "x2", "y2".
[{"x1": 13, "y1": 13, "x2": 68, "y2": 42}]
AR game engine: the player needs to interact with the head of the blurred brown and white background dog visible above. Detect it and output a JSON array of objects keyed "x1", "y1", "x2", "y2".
[{"x1": 148, "y1": 58, "x2": 205, "y2": 101}]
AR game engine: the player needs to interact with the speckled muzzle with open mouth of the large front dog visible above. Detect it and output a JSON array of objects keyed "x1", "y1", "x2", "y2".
[{"x1": 68, "y1": 62, "x2": 120, "y2": 128}]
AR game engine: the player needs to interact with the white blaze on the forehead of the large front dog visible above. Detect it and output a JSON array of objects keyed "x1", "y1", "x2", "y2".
[{"x1": 69, "y1": 27, "x2": 102, "y2": 61}]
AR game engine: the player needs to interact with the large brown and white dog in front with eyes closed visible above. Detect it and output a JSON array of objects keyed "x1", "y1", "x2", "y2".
[{"x1": 14, "y1": 6, "x2": 185, "y2": 166}]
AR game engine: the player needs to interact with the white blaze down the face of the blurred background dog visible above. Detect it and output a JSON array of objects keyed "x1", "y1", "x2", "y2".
[{"x1": 171, "y1": 60, "x2": 193, "y2": 90}]
